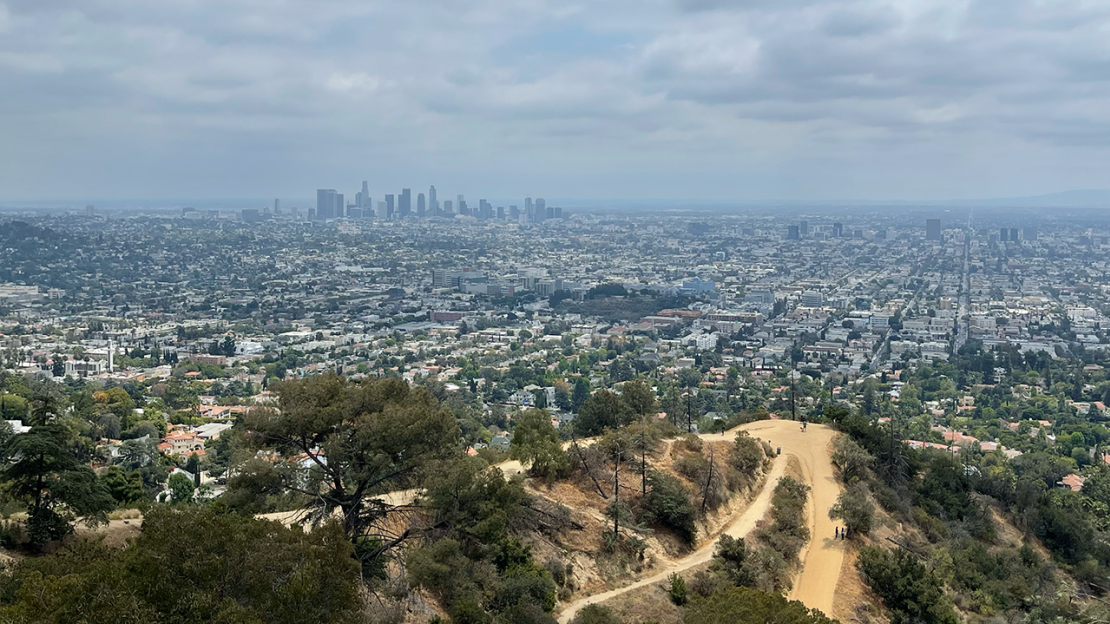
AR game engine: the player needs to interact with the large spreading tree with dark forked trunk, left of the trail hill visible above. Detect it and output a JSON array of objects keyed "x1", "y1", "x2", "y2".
[{"x1": 229, "y1": 373, "x2": 460, "y2": 565}]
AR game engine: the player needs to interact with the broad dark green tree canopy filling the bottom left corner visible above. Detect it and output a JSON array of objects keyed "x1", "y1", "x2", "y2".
[{"x1": 0, "y1": 507, "x2": 364, "y2": 624}]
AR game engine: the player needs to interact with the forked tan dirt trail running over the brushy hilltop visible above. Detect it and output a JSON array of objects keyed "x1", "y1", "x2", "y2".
[{"x1": 558, "y1": 421, "x2": 845, "y2": 624}]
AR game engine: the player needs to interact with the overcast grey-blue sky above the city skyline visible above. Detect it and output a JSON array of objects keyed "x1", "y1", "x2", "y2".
[{"x1": 0, "y1": 0, "x2": 1110, "y2": 200}]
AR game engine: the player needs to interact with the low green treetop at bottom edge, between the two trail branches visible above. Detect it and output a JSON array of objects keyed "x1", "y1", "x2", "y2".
[{"x1": 684, "y1": 587, "x2": 836, "y2": 624}]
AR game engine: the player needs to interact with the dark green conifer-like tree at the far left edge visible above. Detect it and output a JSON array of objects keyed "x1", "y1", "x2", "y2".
[{"x1": 2, "y1": 417, "x2": 115, "y2": 547}]
